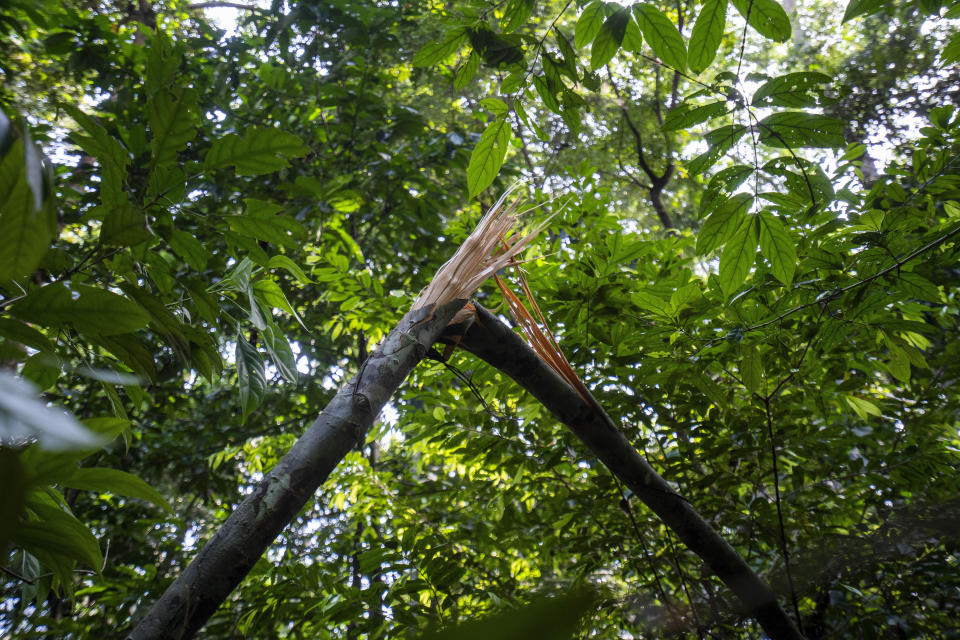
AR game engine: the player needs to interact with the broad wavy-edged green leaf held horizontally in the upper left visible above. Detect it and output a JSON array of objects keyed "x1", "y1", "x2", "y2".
[{"x1": 204, "y1": 127, "x2": 309, "y2": 176}]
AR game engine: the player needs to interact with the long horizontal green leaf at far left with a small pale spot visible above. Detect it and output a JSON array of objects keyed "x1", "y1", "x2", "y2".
[{"x1": 10, "y1": 282, "x2": 150, "y2": 335}]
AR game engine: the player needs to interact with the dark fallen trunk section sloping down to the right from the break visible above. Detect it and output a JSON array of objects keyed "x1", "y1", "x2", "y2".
[{"x1": 460, "y1": 303, "x2": 803, "y2": 640}]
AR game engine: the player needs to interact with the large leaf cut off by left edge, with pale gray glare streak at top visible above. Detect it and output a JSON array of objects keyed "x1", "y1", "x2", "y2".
[{"x1": 0, "y1": 138, "x2": 57, "y2": 283}]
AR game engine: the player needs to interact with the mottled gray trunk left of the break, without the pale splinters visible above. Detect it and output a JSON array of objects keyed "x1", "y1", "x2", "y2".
[{"x1": 128, "y1": 300, "x2": 465, "y2": 640}]
